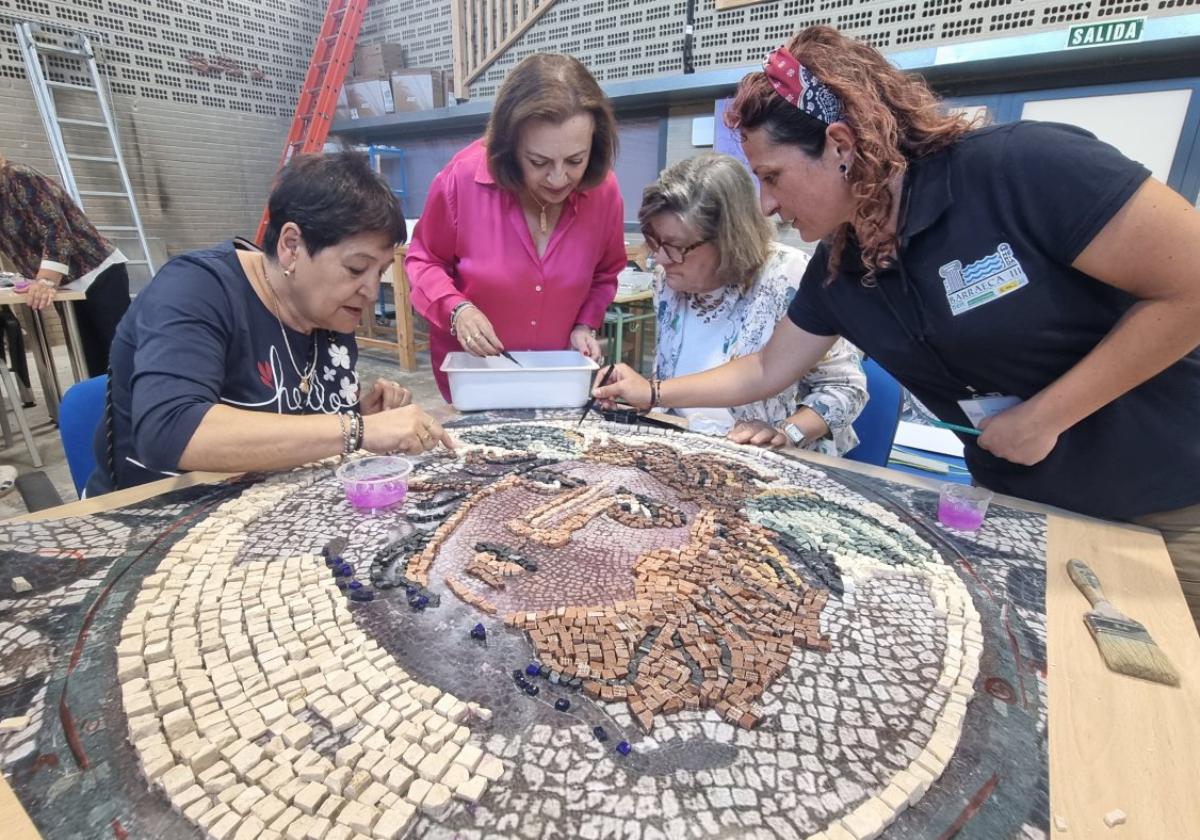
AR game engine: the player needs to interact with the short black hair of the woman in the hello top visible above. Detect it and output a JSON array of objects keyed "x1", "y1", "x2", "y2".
[{"x1": 263, "y1": 151, "x2": 408, "y2": 259}]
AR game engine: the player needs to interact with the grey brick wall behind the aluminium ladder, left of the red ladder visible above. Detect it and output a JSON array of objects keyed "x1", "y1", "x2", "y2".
[{"x1": 0, "y1": 0, "x2": 325, "y2": 262}]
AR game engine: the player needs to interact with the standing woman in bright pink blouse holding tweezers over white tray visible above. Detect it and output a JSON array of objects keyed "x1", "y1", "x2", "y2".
[{"x1": 404, "y1": 53, "x2": 625, "y2": 401}]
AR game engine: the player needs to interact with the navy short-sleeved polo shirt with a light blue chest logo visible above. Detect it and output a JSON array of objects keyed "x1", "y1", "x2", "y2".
[{"x1": 788, "y1": 122, "x2": 1200, "y2": 520}]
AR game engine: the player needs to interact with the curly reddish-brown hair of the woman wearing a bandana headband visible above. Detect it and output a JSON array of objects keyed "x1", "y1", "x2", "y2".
[{"x1": 725, "y1": 26, "x2": 974, "y2": 284}]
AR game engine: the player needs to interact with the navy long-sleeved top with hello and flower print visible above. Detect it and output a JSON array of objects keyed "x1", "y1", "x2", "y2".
[{"x1": 88, "y1": 242, "x2": 359, "y2": 497}]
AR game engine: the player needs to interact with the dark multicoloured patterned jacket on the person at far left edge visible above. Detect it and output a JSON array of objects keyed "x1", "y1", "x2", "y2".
[{"x1": 0, "y1": 161, "x2": 114, "y2": 281}]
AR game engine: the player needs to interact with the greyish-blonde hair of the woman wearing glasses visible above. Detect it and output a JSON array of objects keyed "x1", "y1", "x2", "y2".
[{"x1": 637, "y1": 151, "x2": 775, "y2": 289}]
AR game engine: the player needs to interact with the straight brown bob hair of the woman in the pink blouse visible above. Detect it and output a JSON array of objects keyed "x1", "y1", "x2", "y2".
[{"x1": 484, "y1": 53, "x2": 617, "y2": 192}]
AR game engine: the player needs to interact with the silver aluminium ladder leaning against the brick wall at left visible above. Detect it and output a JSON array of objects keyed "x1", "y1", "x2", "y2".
[{"x1": 16, "y1": 20, "x2": 155, "y2": 280}]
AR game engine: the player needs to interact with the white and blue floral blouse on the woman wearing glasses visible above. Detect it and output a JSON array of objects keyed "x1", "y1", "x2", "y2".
[{"x1": 654, "y1": 242, "x2": 866, "y2": 455}]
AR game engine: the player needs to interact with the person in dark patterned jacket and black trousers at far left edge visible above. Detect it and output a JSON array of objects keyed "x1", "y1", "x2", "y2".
[{"x1": 0, "y1": 154, "x2": 130, "y2": 376}]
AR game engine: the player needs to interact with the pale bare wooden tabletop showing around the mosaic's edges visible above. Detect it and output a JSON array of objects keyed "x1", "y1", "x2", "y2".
[{"x1": 0, "y1": 452, "x2": 1200, "y2": 840}]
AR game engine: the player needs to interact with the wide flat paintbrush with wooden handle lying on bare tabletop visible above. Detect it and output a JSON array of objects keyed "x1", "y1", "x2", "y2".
[{"x1": 1067, "y1": 560, "x2": 1180, "y2": 685}]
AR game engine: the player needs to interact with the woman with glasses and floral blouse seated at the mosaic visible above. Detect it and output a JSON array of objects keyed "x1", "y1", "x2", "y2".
[{"x1": 637, "y1": 152, "x2": 866, "y2": 455}]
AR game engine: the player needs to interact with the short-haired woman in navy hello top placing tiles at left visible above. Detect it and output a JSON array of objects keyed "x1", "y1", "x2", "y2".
[{"x1": 86, "y1": 152, "x2": 454, "y2": 497}]
